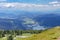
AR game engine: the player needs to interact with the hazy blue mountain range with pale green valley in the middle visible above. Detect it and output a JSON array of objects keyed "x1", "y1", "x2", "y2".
[{"x1": 0, "y1": 12, "x2": 60, "y2": 30}]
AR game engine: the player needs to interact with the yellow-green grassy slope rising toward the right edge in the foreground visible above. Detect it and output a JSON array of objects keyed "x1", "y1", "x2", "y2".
[{"x1": 17, "y1": 27, "x2": 60, "y2": 40}]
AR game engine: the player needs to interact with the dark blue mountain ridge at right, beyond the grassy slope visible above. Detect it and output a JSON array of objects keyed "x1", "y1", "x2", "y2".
[{"x1": 35, "y1": 14, "x2": 60, "y2": 28}]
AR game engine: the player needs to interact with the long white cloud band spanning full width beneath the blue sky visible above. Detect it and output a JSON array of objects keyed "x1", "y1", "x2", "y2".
[{"x1": 0, "y1": 2, "x2": 60, "y2": 11}]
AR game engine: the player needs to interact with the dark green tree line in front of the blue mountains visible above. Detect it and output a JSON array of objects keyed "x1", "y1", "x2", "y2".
[{"x1": 0, "y1": 30, "x2": 42, "y2": 40}]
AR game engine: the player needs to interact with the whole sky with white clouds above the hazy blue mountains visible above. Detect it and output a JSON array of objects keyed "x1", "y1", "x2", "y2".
[{"x1": 0, "y1": 0, "x2": 60, "y2": 12}]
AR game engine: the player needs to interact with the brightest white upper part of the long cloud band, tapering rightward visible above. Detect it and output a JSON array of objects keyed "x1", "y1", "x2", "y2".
[{"x1": 0, "y1": 3, "x2": 48, "y2": 8}]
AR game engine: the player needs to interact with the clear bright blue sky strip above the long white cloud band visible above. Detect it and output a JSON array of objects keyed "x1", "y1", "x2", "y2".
[{"x1": 8, "y1": 0, "x2": 51, "y2": 4}]
